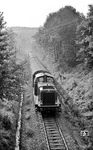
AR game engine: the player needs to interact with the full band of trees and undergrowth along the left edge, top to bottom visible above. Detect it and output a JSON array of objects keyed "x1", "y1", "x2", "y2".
[{"x1": 0, "y1": 12, "x2": 22, "y2": 150}]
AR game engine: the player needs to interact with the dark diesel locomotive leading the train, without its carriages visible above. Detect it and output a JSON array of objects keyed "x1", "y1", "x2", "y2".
[{"x1": 34, "y1": 72, "x2": 60, "y2": 110}]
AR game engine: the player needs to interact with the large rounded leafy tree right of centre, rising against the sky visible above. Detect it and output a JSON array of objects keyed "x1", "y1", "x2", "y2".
[{"x1": 37, "y1": 6, "x2": 84, "y2": 68}]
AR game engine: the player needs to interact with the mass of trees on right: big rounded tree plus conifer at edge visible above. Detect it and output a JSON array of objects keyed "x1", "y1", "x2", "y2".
[{"x1": 36, "y1": 5, "x2": 93, "y2": 71}]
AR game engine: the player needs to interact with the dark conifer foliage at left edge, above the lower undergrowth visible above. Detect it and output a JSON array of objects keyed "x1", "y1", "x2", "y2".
[{"x1": 0, "y1": 13, "x2": 22, "y2": 100}]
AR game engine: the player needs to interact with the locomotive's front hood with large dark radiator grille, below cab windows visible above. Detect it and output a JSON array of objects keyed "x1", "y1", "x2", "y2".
[{"x1": 39, "y1": 83, "x2": 60, "y2": 110}]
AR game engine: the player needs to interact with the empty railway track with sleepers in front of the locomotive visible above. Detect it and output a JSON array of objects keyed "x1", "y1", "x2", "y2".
[{"x1": 43, "y1": 116, "x2": 69, "y2": 150}]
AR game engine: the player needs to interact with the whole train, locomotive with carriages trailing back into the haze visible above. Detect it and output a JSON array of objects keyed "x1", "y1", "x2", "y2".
[{"x1": 31, "y1": 55, "x2": 61, "y2": 111}]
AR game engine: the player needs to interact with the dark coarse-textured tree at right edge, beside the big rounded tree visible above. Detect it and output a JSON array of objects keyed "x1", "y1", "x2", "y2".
[{"x1": 76, "y1": 5, "x2": 93, "y2": 67}]
